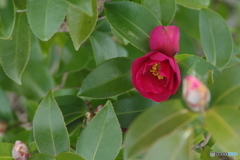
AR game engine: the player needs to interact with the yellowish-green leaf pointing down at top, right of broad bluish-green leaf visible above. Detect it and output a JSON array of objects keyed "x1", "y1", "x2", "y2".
[{"x1": 67, "y1": 0, "x2": 98, "y2": 50}]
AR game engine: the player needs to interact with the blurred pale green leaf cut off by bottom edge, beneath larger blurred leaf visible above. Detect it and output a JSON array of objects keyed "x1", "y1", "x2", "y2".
[{"x1": 144, "y1": 128, "x2": 194, "y2": 160}]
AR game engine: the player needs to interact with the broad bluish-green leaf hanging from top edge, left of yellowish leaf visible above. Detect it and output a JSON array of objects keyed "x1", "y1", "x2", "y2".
[{"x1": 27, "y1": 0, "x2": 67, "y2": 41}]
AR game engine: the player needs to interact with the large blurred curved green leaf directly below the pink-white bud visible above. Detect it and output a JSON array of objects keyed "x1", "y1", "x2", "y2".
[{"x1": 124, "y1": 100, "x2": 195, "y2": 159}]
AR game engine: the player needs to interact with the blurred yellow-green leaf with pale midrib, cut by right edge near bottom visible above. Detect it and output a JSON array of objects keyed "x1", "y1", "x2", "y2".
[{"x1": 205, "y1": 106, "x2": 240, "y2": 156}]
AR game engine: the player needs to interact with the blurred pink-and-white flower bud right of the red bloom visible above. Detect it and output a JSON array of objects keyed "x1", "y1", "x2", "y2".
[{"x1": 183, "y1": 76, "x2": 210, "y2": 112}]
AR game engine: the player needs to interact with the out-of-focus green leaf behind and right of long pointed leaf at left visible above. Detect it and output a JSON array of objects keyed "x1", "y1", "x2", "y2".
[{"x1": 18, "y1": 34, "x2": 54, "y2": 100}]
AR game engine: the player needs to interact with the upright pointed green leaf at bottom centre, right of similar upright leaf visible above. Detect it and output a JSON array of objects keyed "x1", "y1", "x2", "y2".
[{"x1": 76, "y1": 101, "x2": 122, "y2": 160}]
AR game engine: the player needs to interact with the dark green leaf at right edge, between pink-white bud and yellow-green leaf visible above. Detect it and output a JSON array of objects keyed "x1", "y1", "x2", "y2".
[{"x1": 210, "y1": 65, "x2": 240, "y2": 107}]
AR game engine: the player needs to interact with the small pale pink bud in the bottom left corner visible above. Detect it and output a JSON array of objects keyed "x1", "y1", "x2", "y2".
[{"x1": 12, "y1": 141, "x2": 30, "y2": 160}]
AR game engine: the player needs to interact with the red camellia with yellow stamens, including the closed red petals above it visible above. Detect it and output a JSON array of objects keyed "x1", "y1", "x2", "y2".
[{"x1": 132, "y1": 26, "x2": 181, "y2": 102}]
